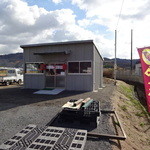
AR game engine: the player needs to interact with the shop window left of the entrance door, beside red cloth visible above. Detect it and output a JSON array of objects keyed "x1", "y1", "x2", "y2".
[{"x1": 25, "y1": 63, "x2": 44, "y2": 73}]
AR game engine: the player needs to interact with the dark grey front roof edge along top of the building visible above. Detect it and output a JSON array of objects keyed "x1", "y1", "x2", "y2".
[{"x1": 20, "y1": 40, "x2": 93, "y2": 48}]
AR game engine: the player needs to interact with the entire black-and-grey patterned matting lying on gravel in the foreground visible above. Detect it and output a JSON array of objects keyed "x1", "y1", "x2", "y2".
[{"x1": 0, "y1": 125, "x2": 87, "y2": 150}]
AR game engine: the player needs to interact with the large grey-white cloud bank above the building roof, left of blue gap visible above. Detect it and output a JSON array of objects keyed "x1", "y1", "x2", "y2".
[{"x1": 0, "y1": 0, "x2": 112, "y2": 58}]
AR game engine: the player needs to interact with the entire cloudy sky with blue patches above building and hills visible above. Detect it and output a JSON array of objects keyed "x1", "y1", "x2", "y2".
[{"x1": 0, "y1": 0, "x2": 150, "y2": 59}]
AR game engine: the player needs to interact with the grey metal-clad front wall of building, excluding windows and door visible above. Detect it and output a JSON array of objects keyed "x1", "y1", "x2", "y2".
[{"x1": 24, "y1": 43, "x2": 94, "y2": 91}]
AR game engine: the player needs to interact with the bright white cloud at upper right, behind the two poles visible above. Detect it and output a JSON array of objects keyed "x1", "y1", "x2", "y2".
[{"x1": 72, "y1": 0, "x2": 150, "y2": 58}]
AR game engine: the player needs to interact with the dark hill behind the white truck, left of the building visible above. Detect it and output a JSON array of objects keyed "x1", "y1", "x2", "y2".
[{"x1": 0, "y1": 53, "x2": 23, "y2": 68}]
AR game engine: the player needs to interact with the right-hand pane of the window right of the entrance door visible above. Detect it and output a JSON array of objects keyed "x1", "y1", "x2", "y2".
[{"x1": 80, "y1": 62, "x2": 92, "y2": 73}]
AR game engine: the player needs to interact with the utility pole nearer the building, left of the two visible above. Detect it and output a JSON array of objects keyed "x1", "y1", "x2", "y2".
[{"x1": 114, "y1": 30, "x2": 117, "y2": 85}]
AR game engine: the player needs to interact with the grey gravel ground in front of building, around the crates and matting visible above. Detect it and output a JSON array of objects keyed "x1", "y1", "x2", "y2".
[{"x1": 0, "y1": 84, "x2": 114, "y2": 150}]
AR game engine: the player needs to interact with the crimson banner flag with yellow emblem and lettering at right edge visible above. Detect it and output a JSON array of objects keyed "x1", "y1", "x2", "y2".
[{"x1": 138, "y1": 47, "x2": 150, "y2": 112}]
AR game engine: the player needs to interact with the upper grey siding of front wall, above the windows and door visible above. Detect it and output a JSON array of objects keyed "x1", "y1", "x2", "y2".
[{"x1": 24, "y1": 43, "x2": 93, "y2": 62}]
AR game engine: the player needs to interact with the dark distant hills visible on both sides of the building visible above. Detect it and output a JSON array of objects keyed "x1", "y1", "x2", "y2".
[{"x1": 0, "y1": 53, "x2": 139, "y2": 68}]
